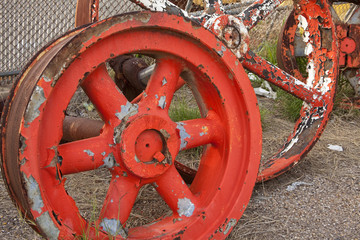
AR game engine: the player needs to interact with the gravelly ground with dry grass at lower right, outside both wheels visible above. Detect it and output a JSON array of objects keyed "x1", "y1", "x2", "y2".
[{"x1": 229, "y1": 116, "x2": 360, "y2": 239}]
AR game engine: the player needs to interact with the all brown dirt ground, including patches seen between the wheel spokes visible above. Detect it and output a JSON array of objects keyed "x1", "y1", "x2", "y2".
[{"x1": 0, "y1": 101, "x2": 360, "y2": 240}]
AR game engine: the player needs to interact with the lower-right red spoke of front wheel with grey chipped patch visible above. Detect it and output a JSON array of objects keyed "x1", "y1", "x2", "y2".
[{"x1": 154, "y1": 165, "x2": 197, "y2": 217}]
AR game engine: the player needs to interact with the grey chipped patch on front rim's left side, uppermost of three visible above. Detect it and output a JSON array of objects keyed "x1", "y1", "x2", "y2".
[{"x1": 24, "y1": 86, "x2": 46, "y2": 127}]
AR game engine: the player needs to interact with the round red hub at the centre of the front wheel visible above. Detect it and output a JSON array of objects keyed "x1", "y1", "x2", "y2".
[{"x1": 118, "y1": 115, "x2": 180, "y2": 178}]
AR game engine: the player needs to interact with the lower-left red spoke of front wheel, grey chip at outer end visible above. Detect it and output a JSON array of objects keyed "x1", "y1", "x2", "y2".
[{"x1": 99, "y1": 171, "x2": 141, "y2": 231}]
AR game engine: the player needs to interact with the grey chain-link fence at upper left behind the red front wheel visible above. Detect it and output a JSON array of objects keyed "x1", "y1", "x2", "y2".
[{"x1": 0, "y1": 0, "x2": 140, "y2": 84}]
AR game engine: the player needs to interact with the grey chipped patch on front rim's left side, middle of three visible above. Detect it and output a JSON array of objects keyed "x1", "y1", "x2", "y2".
[{"x1": 23, "y1": 173, "x2": 44, "y2": 214}]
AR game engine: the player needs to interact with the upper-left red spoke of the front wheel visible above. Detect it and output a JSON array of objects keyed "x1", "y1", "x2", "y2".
[{"x1": 81, "y1": 64, "x2": 128, "y2": 122}]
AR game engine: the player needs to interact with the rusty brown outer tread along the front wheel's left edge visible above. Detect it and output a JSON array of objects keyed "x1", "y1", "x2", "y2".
[{"x1": 1, "y1": 27, "x2": 83, "y2": 235}]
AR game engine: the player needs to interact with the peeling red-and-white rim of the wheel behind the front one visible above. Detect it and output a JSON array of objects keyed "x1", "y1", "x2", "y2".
[{"x1": 253, "y1": 1, "x2": 339, "y2": 181}]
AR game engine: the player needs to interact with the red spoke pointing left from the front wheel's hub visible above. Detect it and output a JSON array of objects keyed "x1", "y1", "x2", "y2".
[{"x1": 57, "y1": 136, "x2": 115, "y2": 175}]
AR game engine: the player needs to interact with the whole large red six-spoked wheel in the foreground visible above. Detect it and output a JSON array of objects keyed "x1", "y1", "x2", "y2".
[{"x1": 1, "y1": 12, "x2": 261, "y2": 239}]
